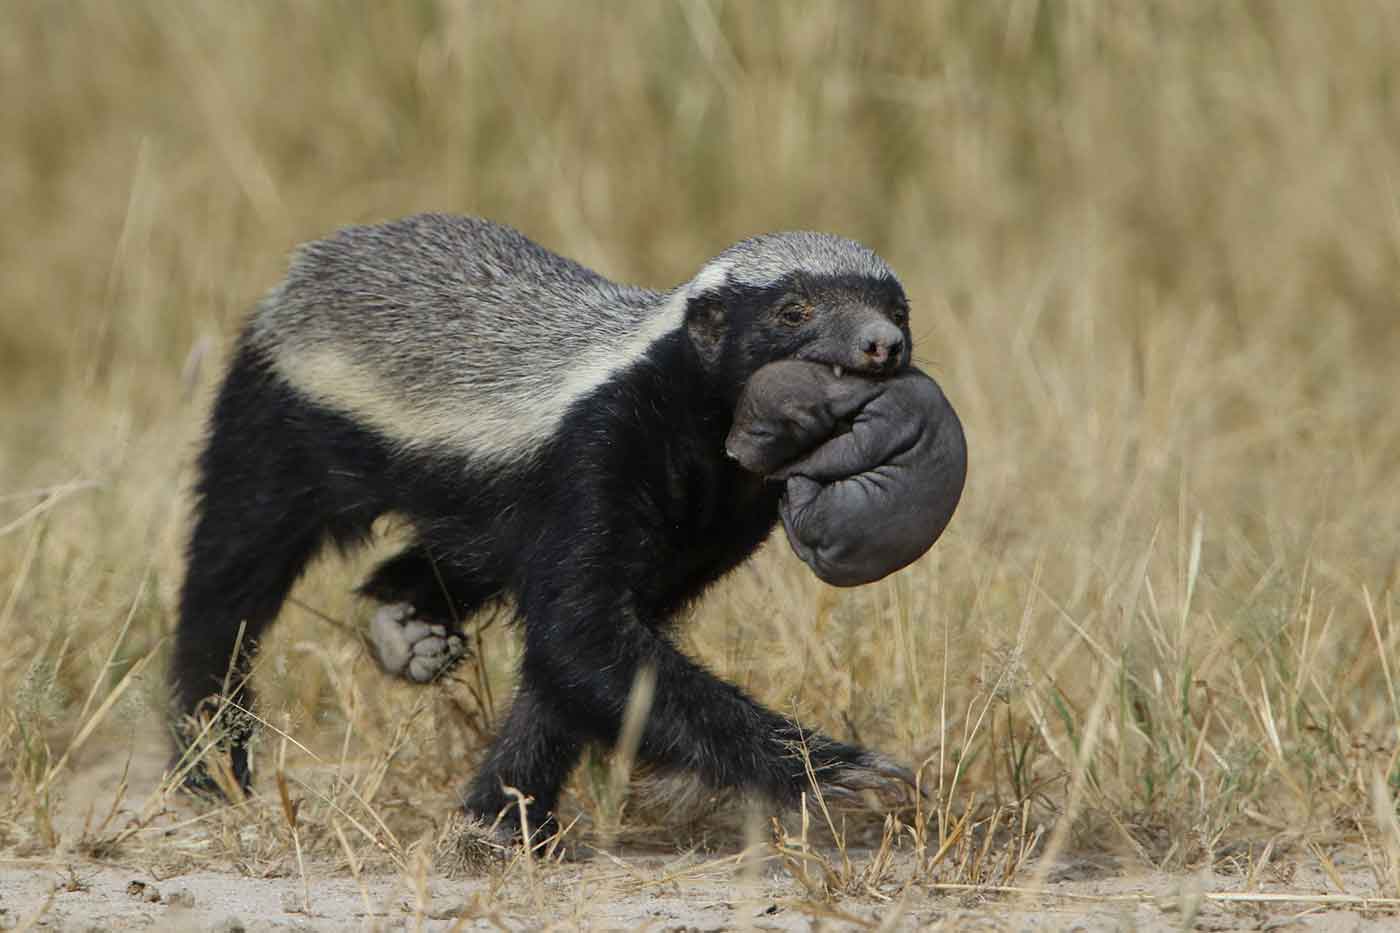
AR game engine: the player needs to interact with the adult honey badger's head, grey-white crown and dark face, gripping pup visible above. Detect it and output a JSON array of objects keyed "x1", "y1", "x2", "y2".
[{"x1": 683, "y1": 233, "x2": 913, "y2": 396}]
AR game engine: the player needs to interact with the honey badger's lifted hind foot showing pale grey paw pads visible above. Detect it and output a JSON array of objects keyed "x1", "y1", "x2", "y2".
[{"x1": 360, "y1": 545, "x2": 500, "y2": 684}]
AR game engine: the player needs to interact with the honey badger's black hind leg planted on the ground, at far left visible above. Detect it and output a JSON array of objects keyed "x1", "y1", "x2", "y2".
[{"x1": 171, "y1": 345, "x2": 375, "y2": 790}]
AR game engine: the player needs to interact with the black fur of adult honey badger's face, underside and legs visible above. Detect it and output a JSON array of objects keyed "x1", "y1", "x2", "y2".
[{"x1": 172, "y1": 259, "x2": 910, "y2": 827}]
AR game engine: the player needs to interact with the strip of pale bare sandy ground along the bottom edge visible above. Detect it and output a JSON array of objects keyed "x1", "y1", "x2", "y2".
[{"x1": 0, "y1": 856, "x2": 1400, "y2": 933}]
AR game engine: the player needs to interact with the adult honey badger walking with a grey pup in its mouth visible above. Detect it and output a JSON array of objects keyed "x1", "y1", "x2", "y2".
[{"x1": 172, "y1": 214, "x2": 911, "y2": 831}]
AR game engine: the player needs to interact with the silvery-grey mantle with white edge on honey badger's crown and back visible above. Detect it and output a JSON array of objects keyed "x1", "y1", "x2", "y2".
[{"x1": 251, "y1": 214, "x2": 890, "y2": 461}]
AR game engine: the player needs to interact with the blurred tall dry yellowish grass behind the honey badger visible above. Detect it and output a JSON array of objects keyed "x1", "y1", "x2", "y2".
[{"x1": 0, "y1": 0, "x2": 1400, "y2": 863}]
